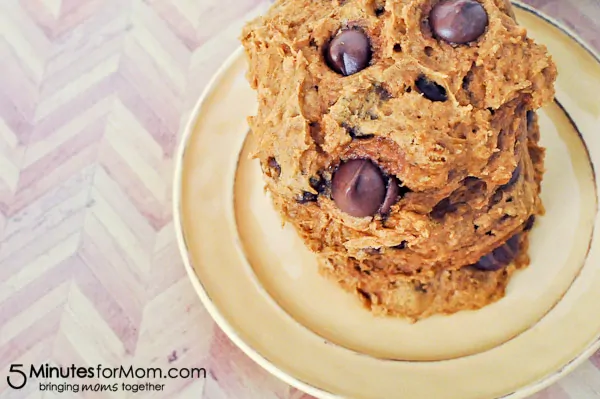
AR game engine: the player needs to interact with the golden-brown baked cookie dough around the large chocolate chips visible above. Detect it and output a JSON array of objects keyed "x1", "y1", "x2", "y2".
[{"x1": 241, "y1": 0, "x2": 556, "y2": 321}]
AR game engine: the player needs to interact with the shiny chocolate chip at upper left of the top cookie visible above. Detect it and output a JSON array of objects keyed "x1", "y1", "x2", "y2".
[{"x1": 325, "y1": 29, "x2": 371, "y2": 76}]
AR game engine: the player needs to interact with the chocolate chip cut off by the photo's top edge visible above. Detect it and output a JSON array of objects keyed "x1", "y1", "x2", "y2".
[{"x1": 429, "y1": 0, "x2": 488, "y2": 44}]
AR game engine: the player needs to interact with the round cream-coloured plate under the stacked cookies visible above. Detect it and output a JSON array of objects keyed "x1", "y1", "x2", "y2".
[{"x1": 174, "y1": 3, "x2": 600, "y2": 399}]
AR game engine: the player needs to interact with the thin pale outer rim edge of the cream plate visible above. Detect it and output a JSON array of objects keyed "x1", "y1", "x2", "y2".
[{"x1": 172, "y1": 0, "x2": 600, "y2": 399}]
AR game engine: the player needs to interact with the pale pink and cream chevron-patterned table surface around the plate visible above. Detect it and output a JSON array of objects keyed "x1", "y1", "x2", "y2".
[{"x1": 0, "y1": 0, "x2": 600, "y2": 399}]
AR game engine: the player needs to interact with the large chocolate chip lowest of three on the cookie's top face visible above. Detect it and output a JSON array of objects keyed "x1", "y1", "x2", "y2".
[{"x1": 331, "y1": 159, "x2": 386, "y2": 217}]
